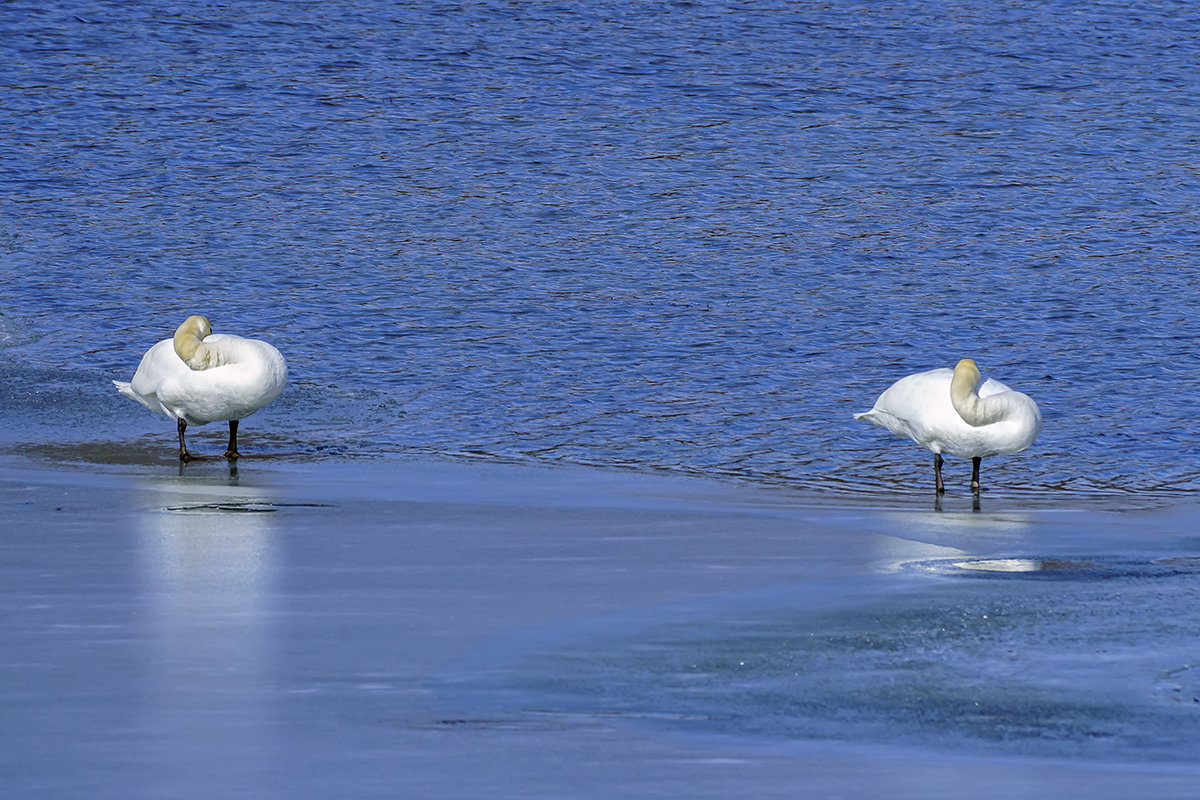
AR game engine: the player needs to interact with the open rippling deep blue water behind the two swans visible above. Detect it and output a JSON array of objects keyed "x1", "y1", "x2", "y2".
[{"x1": 0, "y1": 0, "x2": 1200, "y2": 493}]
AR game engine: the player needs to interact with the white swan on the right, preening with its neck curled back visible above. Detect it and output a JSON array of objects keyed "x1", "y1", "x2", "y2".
[{"x1": 854, "y1": 359, "x2": 1042, "y2": 493}]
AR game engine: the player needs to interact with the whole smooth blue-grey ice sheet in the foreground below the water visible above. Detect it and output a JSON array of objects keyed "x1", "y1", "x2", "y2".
[{"x1": 0, "y1": 457, "x2": 1200, "y2": 799}]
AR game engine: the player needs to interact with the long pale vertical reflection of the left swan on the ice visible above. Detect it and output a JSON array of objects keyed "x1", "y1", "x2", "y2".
[{"x1": 140, "y1": 481, "x2": 275, "y2": 796}]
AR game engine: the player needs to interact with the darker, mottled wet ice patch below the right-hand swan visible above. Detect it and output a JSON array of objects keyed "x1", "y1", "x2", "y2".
[{"x1": 439, "y1": 566, "x2": 1200, "y2": 762}]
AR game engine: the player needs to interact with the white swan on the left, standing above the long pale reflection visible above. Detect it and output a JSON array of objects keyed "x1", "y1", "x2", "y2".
[{"x1": 113, "y1": 317, "x2": 288, "y2": 461}]
